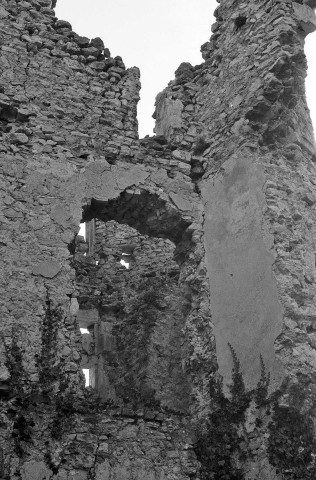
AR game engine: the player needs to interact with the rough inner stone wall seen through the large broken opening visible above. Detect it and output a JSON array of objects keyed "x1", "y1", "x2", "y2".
[{"x1": 75, "y1": 220, "x2": 190, "y2": 412}]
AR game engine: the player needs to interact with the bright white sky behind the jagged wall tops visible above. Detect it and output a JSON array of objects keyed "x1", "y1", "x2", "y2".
[{"x1": 55, "y1": 0, "x2": 316, "y2": 138}]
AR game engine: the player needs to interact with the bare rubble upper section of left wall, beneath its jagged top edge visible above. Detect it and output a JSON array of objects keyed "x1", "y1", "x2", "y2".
[{"x1": 1, "y1": 2, "x2": 139, "y2": 162}]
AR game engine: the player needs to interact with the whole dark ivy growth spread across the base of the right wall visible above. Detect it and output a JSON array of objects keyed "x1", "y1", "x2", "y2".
[{"x1": 195, "y1": 345, "x2": 316, "y2": 480}]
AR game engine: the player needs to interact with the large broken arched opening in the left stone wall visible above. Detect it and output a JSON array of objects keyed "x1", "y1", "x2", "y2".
[{"x1": 74, "y1": 191, "x2": 192, "y2": 411}]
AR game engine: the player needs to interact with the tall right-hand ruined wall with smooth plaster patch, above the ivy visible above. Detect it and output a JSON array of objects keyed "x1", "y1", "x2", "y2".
[{"x1": 156, "y1": 1, "x2": 316, "y2": 394}]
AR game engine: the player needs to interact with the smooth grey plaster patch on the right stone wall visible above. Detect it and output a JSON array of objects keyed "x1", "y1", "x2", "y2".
[{"x1": 202, "y1": 156, "x2": 282, "y2": 386}]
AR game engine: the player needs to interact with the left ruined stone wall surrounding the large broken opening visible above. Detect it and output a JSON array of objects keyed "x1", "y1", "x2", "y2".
[{"x1": 0, "y1": 0, "x2": 210, "y2": 480}]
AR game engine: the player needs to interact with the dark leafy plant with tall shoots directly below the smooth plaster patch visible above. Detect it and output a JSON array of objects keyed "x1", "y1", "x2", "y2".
[{"x1": 195, "y1": 344, "x2": 270, "y2": 480}]
